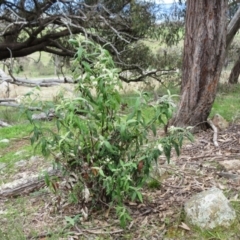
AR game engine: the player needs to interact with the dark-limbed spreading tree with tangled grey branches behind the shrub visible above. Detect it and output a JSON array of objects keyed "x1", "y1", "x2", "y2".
[{"x1": 0, "y1": 0, "x2": 188, "y2": 82}]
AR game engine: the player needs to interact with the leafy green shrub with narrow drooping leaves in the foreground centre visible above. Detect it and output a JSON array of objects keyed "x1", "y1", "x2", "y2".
[{"x1": 28, "y1": 39, "x2": 193, "y2": 226}]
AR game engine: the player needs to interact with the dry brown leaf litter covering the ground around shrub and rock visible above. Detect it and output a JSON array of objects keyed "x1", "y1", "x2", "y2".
[{"x1": 0, "y1": 125, "x2": 240, "y2": 239}]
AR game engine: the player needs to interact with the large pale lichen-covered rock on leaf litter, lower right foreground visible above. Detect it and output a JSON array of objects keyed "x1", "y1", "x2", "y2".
[{"x1": 184, "y1": 188, "x2": 236, "y2": 229}]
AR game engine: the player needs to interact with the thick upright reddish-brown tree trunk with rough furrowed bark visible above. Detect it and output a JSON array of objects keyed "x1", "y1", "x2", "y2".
[{"x1": 169, "y1": 0, "x2": 227, "y2": 130}]
